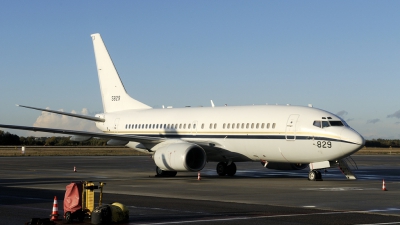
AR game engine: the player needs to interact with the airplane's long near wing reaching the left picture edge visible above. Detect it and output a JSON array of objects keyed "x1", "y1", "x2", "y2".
[{"x1": 0, "y1": 124, "x2": 166, "y2": 144}]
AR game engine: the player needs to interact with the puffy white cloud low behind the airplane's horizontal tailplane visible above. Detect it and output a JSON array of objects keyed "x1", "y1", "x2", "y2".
[{"x1": 28, "y1": 107, "x2": 99, "y2": 137}]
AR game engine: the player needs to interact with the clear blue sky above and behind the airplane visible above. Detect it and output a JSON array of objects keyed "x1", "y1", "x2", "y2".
[{"x1": 0, "y1": 0, "x2": 400, "y2": 139}]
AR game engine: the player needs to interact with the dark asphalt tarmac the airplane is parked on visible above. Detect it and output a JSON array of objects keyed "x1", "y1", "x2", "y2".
[{"x1": 0, "y1": 155, "x2": 400, "y2": 224}]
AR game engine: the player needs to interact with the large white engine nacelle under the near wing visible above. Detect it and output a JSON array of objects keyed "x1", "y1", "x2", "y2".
[{"x1": 153, "y1": 142, "x2": 207, "y2": 172}]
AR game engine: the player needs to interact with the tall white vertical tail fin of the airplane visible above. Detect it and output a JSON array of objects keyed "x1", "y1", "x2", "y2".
[{"x1": 91, "y1": 34, "x2": 151, "y2": 113}]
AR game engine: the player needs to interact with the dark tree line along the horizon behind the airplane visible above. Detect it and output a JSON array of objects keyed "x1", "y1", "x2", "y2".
[{"x1": 0, "y1": 130, "x2": 400, "y2": 148}]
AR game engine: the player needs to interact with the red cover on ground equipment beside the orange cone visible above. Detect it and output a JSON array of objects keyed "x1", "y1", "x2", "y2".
[{"x1": 64, "y1": 182, "x2": 82, "y2": 215}]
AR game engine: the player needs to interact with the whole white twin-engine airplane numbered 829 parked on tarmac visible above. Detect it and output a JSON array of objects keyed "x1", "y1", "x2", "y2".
[{"x1": 0, "y1": 34, "x2": 365, "y2": 180}]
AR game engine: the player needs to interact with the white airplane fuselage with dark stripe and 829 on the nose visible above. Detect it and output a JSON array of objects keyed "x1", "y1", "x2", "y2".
[{"x1": 96, "y1": 105, "x2": 364, "y2": 163}]
